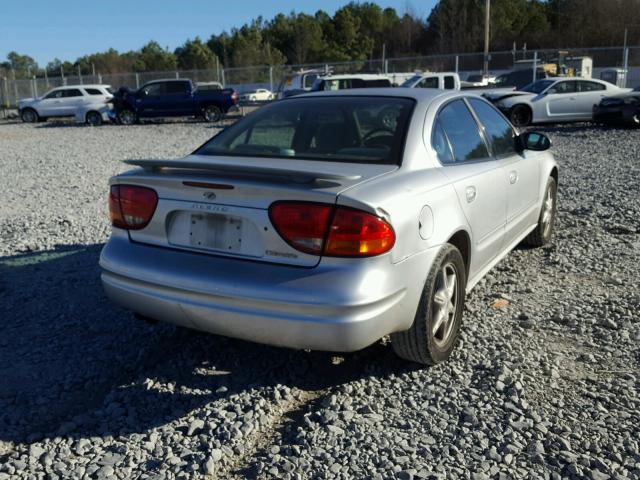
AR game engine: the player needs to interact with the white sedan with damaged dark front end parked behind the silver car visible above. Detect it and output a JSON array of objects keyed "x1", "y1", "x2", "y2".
[{"x1": 485, "y1": 77, "x2": 628, "y2": 127}]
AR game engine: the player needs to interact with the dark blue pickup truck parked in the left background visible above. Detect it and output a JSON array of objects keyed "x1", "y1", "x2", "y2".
[{"x1": 111, "y1": 79, "x2": 238, "y2": 125}]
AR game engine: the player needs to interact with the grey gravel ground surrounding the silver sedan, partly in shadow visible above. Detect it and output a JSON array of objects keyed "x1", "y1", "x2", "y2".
[{"x1": 0, "y1": 123, "x2": 640, "y2": 480}]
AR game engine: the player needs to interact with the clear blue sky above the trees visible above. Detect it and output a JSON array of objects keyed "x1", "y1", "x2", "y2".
[{"x1": 0, "y1": 0, "x2": 436, "y2": 66}]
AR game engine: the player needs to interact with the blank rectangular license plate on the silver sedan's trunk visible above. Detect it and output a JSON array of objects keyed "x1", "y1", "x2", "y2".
[{"x1": 189, "y1": 213, "x2": 242, "y2": 253}]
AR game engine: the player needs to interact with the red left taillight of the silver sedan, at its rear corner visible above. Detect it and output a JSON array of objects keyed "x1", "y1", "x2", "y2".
[{"x1": 109, "y1": 185, "x2": 158, "y2": 230}]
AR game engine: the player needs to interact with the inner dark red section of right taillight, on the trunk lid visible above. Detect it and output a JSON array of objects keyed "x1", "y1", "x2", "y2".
[{"x1": 269, "y1": 202, "x2": 333, "y2": 255}]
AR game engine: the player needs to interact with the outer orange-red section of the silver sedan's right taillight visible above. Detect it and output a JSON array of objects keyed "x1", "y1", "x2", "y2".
[{"x1": 324, "y1": 207, "x2": 396, "y2": 257}]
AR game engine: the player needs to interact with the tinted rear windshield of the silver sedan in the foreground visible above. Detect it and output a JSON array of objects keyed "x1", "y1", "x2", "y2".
[{"x1": 195, "y1": 96, "x2": 414, "y2": 165}]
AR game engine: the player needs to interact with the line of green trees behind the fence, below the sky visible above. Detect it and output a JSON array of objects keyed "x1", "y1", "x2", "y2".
[{"x1": 0, "y1": 0, "x2": 640, "y2": 77}]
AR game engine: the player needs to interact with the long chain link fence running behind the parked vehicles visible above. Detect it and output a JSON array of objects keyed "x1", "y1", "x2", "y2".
[{"x1": 0, "y1": 46, "x2": 640, "y2": 108}]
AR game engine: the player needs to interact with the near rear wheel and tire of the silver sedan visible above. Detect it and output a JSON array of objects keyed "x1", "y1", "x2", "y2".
[{"x1": 391, "y1": 244, "x2": 467, "y2": 365}]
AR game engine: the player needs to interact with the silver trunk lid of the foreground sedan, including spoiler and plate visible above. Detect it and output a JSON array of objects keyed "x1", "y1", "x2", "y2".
[{"x1": 112, "y1": 155, "x2": 398, "y2": 267}]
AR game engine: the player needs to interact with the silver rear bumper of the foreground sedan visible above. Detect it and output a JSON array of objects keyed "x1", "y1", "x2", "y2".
[{"x1": 100, "y1": 233, "x2": 437, "y2": 351}]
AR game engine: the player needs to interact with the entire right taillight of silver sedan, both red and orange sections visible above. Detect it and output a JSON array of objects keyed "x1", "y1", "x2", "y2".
[{"x1": 269, "y1": 202, "x2": 396, "y2": 257}]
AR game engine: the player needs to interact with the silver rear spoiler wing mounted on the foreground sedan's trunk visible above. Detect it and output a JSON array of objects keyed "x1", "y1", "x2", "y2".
[{"x1": 124, "y1": 160, "x2": 362, "y2": 182}]
